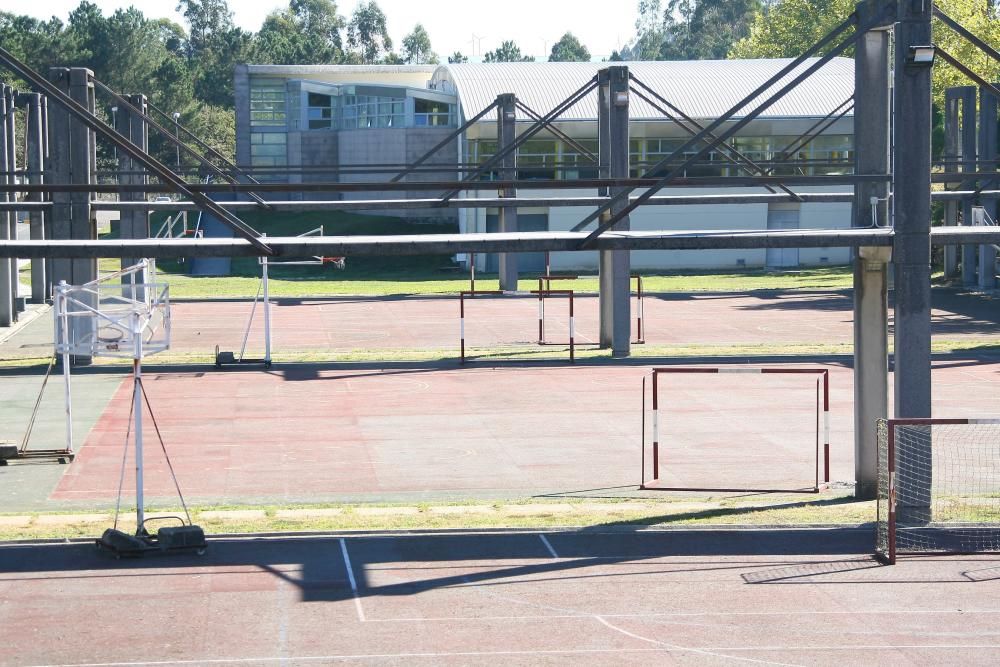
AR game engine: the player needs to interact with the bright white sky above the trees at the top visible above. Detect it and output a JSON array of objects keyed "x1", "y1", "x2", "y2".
[{"x1": 13, "y1": 0, "x2": 639, "y2": 61}]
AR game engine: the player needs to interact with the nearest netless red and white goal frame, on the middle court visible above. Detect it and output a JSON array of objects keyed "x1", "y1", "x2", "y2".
[{"x1": 639, "y1": 366, "x2": 830, "y2": 493}]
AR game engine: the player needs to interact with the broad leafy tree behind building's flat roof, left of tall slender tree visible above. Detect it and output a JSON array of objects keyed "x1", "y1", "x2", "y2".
[{"x1": 254, "y1": 0, "x2": 344, "y2": 65}]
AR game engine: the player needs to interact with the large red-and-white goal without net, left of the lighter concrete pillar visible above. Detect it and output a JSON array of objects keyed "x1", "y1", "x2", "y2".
[{"x1": 641, "y1": 366, "x2": 830, "y2": 492}]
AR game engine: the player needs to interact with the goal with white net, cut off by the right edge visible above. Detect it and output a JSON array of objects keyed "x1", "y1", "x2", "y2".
[{"x1": 875, "y1": 418, "x2": 1000, "y2": 565}]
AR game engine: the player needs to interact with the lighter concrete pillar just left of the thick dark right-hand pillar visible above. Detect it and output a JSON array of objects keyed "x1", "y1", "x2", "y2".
[{"x1": 852, "y1": 30, "x2": 892, "y2": 498}]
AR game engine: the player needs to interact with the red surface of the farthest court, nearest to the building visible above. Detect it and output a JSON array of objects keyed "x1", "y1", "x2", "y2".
[{"x1": 171, "y1": 291, "x2": 1000, "y2": 355}]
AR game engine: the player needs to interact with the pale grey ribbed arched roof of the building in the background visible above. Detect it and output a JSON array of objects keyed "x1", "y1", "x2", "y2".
[{"x1": 433, "y1": 58, "x2": 854, "y2": 120}]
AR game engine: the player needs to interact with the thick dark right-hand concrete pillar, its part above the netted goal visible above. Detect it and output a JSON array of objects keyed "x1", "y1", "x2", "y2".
[{"x1": 893, "y1": 2, "x2": 932, "y2": 417}]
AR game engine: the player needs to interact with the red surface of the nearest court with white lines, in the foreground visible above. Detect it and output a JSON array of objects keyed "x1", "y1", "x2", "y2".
[{"x1": 0, "y1": 529, "x2": 1000, "y2": 667}]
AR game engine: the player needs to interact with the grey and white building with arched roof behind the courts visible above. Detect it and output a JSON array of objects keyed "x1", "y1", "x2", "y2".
[{"x1": 236, "y1": 58, "x2": 854, "y2": 270}]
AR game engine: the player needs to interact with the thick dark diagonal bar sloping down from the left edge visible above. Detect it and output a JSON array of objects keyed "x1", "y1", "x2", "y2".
[{"x1": 0, "y1": 47, "x2": 271, "y2": 255}]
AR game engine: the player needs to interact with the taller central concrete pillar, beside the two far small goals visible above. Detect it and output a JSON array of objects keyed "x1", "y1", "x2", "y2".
[{"x1": 598, "y1": 66, "x2": 632, "y2": 357}]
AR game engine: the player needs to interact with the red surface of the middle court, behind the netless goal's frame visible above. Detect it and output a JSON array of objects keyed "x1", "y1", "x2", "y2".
[{"x1": 51, "y1": 359, "x2": 1000, "y2": 503}]
